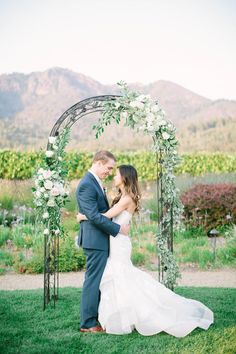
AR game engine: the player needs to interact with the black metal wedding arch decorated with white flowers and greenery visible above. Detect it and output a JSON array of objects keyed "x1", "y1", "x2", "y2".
[{"x1": 33, "y1": 82, "x2": 183, "y2": 309}]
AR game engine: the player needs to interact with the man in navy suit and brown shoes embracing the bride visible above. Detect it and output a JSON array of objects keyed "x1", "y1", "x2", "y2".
[{"x1": 76, "y1": 151, "x2": 129, "y2": 332}]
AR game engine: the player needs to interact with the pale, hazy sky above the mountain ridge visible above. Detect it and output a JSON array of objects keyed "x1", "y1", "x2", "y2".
[{"x1": 0, "y1": 0, "x2": 236, "y2": 99}]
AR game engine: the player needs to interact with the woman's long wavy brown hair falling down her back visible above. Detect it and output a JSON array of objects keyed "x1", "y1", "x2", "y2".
[{"x1": 112, "y1": 165, "x2": 141, "y2": 212}]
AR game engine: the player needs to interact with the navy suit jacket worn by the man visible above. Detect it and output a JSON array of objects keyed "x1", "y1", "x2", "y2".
[{"x1": 76, "y1": 172, "x2": 120, "y2": 251}]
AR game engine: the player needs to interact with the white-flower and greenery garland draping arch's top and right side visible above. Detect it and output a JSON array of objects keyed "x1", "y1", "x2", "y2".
[{"x1": 94, "y1": 81, "x2": 183, "y2": 287}]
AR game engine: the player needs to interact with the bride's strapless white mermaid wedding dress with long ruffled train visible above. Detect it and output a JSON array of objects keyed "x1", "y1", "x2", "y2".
[{"x1": 98, "y1": 210, "x2": 213, "y2": 337}]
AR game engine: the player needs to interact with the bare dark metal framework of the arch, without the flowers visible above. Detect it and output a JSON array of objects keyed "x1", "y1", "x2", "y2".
[{"x1": 43, "y1": 95, "x2": 173, "y2": 310}]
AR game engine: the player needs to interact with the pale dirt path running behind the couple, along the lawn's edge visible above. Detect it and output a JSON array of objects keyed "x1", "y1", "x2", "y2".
[{"x1": 0, "y1": 269, "x2": 236, "y2": 290}]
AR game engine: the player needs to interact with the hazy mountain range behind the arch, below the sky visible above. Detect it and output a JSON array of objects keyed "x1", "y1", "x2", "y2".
[{"x1": 0, "y1": 68, "x2": 236, "y2": 152}]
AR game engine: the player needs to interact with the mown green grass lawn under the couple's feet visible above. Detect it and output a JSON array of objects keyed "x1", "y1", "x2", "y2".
[{"x1": 0, "y1": 287, "x2": 236, "y2": 354}]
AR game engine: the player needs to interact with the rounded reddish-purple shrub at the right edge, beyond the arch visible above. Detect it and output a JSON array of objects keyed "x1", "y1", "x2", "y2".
[{"x1": 181, "y1": 183, "x2": 236, "y2": 230}]
